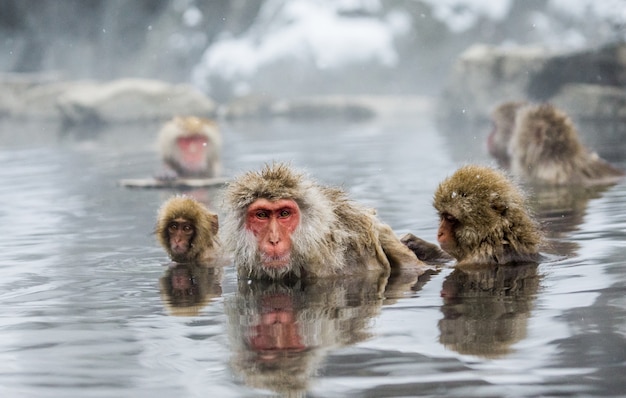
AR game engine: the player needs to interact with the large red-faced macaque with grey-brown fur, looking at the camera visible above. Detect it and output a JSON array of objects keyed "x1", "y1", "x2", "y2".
[{"x1": 224, "y1": 163, "x2": 423, "y2": 279}]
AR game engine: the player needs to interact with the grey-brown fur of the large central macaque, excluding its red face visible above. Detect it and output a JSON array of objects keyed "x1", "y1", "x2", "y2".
[{"x1": 224, "y1": 163, "x2": 420, "y2": 279}]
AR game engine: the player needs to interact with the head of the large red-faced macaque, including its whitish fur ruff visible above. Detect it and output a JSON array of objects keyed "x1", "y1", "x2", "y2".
[{"x1": 224, "y1": 163, "x2": 341, "y2": 279}]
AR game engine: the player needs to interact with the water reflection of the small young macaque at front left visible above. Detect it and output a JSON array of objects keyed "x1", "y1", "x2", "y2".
[{"x1": 159, "y1": 264, "x2": 223, "y2": 316}]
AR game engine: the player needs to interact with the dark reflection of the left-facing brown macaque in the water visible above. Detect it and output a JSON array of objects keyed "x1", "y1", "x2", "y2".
[{"x1": 439, "y1": 263, "x2": 541, "y2": 358}]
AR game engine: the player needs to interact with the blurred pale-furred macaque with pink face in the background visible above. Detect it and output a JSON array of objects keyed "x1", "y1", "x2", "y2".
[{"x1": 158, "y1": 116, "x2": 222, "y2": 178}]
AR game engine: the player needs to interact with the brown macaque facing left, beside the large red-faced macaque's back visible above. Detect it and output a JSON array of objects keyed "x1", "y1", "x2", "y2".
[{"x1": 433, "y1": 165, "x2": 542, "y2": 264}]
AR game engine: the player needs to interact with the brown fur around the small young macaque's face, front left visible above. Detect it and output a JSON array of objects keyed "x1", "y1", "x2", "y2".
[{"x1": 155, "y1": 196, "x2": 219, "y2": 263}]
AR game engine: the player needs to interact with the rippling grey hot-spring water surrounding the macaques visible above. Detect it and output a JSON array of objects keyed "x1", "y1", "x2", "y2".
[{"x1": 0, "y1": 109, "x2": 626, "y2": 398}]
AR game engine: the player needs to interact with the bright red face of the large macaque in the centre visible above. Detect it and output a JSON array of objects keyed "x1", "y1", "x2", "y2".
[{"x1": 246, "y1": 199, "x2": 300, "y2": 268}]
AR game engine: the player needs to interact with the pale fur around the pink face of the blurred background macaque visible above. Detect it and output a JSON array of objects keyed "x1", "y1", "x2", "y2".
[{"x1": 158, "y1": 116, "x2": 222, "y2": 178}]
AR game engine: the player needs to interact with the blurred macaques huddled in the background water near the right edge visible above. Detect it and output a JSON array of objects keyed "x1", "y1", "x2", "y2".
[{"x1": 488, "y1": 103, "x2": 624, "y2": 185}]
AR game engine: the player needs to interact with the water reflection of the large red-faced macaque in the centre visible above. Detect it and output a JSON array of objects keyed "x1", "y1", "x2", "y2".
[{"x1": 225, "y1": 277, "x2": 386, "y2": 395}]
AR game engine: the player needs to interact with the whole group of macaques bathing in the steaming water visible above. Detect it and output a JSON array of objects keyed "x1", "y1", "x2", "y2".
[{"x1": 156, "y1": 102, "x2": 624, "y2": 280}]
